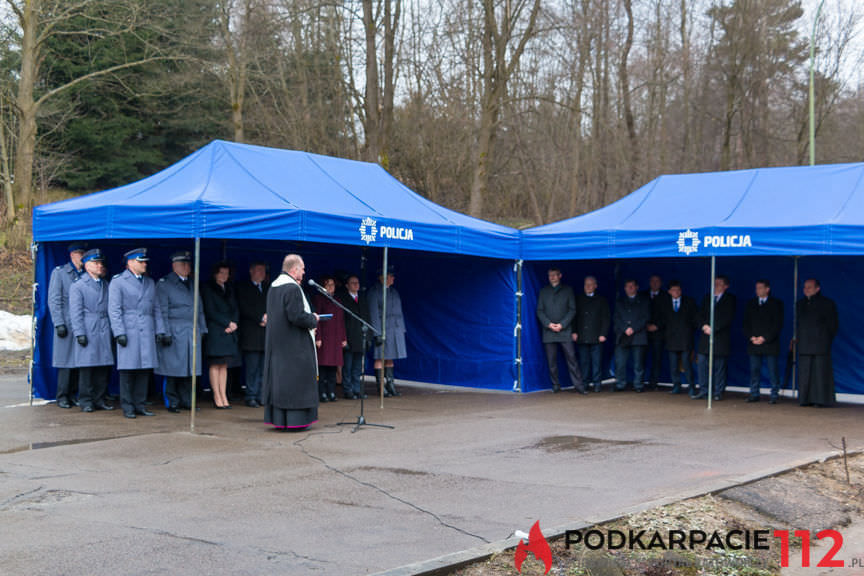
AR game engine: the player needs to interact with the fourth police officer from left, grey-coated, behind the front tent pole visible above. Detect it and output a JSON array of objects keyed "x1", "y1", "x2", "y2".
[{"x1": 156, "y1": 250, "x2": 207, "y2": 412}]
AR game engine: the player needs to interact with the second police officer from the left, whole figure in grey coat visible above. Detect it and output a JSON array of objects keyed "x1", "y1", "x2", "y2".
[{"x1": 69, "y1": 248, "x2": 114, "y2": 412}]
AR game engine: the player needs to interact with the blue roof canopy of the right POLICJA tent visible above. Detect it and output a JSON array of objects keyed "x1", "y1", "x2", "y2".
[{"x1": 522, "y1": 163, "x2": 864, "y2": 260}]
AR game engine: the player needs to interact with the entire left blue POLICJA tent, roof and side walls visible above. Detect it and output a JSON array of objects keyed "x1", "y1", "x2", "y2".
[{"x1": 32, "y1": 140, "x2": 519, "y2": 398}]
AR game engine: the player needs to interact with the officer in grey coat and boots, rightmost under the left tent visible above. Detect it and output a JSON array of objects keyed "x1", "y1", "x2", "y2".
[{"x1": 366, "y1": 266, "x2": 408, "y2": 396}]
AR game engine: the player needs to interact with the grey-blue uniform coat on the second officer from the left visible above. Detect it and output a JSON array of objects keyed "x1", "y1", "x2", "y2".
[{"x1": 67, "y1": 274, "x2": 114, "y2": 368}]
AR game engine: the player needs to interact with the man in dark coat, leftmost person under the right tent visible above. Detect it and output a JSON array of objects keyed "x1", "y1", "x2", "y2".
[{"x1": 537, "y1": 268, "x2": 586, "y2": 394}]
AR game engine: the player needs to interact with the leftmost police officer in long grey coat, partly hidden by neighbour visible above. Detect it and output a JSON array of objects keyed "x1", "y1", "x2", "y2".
[{"x1": 48, "y1": 242, "x2": 87, "y2": 408}]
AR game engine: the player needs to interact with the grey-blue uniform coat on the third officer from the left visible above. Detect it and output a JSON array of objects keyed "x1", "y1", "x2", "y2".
[{"x1": 108, "y1": 270, "x2": 166, "y2": 370}]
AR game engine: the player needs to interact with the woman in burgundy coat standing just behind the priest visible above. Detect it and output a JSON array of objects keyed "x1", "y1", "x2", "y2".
[{"x1": 312, "y1": 278, "x2": 348, "y2": 402}]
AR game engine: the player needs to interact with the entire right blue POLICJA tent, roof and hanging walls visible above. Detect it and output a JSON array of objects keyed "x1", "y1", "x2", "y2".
[{"x1": 522, "y1": 163, "x2": 864, "y2": 393}]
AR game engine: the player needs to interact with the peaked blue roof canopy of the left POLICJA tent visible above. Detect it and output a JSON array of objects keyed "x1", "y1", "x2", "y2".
[{"x1": 33, "y1": 140, "x2": 519, "y2": 258}]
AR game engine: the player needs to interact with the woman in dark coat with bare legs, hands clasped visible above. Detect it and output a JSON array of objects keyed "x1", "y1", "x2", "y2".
[{"x1": 201, "y1": 262, "x2": 240, "y2": 409}]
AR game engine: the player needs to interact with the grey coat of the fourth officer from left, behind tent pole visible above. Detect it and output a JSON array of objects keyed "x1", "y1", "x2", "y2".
[{"x1": 156, "y1": 272, "x2": 207, "y2": 378}]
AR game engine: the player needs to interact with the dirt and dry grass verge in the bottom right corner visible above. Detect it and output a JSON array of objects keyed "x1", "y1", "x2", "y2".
[{"x1": 449, "y1": 454, "x2": 864, "y2": 576}]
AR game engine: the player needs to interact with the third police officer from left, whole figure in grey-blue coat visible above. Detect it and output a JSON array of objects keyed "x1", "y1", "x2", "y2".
[{"x1": 108, "y1": 248, "x2": 167, "y2": 418}]
